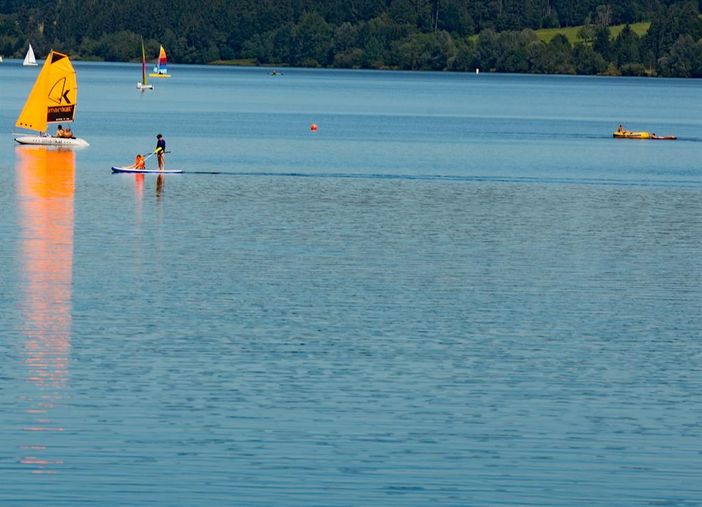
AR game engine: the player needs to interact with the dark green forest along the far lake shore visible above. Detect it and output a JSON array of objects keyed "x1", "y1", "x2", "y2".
[{"x1": 0, "y1": 0, "x2": 702, "y2": 77}]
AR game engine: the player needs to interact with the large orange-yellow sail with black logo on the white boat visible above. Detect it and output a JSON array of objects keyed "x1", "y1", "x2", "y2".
[{"x1": 15, "y1": 51, "x2": 78, "y2": 132}]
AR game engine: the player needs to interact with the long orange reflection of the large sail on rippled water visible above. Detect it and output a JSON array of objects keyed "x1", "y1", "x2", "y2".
[{"x1": 16, "y1": 146, "x2": 75, "y2": 473}]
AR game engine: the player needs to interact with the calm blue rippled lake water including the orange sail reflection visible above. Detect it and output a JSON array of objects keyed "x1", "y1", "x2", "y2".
[{"x1": 0, "y1": 61, "x2": 702, "y2": 506}]
